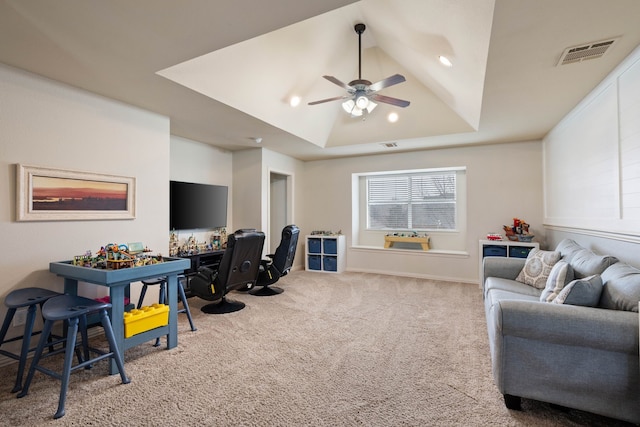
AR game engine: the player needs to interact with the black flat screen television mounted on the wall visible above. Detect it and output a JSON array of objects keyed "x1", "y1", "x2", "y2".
[{"x1": 169, "y1": 181, "x2": 229, "y2": 230}]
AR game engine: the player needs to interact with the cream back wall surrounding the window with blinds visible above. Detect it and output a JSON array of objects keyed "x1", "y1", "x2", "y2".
[{"x1": 299, "y1": 141, "x2": 544, "y2": 282}]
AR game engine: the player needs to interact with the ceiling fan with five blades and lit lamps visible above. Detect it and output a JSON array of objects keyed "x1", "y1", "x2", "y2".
[{"x1": 308, "y1": 23, "x2": 409, "y2": 117}]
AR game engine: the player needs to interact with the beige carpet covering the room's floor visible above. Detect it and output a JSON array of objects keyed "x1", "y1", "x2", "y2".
[{"x1": 0, "y1": 271, "x2": 626, "y2": 426}]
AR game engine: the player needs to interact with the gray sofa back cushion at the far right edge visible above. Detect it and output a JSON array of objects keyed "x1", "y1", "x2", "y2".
[{"x1": 600, "y1": 263, "x2": 640, "y2": 312}]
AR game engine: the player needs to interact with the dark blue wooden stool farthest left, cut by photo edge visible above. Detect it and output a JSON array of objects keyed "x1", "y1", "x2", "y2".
[{"x1": 0, "y1": 288, "x2": 62, "y2": 393}]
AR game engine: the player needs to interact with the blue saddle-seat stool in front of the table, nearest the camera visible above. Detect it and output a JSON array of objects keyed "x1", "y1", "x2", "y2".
[{"x1": 18, "y1": 295, "x2": 130, "y2": 418}]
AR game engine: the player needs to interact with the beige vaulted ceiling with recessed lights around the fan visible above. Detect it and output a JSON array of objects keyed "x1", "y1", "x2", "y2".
[{"x1": 0, "y1": 0, "x2": 640, "y2": 159}]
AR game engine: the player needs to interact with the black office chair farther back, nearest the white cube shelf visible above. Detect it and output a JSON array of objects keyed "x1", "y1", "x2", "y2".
[{"x1": 249, "y1": 224, "x2": 300, "y2": 296}]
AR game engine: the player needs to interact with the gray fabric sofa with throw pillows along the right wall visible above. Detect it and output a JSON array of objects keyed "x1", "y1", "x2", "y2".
[{"x1": 483, "y1": 239, "x2": 640, "y2": 424}]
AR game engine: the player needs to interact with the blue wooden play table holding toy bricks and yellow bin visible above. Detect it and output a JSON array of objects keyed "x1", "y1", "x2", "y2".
[{"x1": 49, "y1": 258, "x2": 191, "y2": 375}]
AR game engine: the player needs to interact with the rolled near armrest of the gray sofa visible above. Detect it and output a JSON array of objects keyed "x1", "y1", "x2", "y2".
[{"x1": 491, "y1": 300, "x2": 639, "y2": 355}]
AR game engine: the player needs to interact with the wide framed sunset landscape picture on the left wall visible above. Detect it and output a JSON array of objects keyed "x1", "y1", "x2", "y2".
[{"x1": 16, "y1": 164, "x2": 136, "y2": 221}]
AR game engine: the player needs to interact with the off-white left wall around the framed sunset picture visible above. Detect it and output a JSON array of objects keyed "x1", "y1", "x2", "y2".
[{"x1": 0, "y1": 65, "x2": 169, "y2": 358}]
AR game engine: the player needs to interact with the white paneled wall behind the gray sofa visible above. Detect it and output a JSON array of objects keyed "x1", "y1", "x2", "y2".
[{"x1": 543, "y1": 44, "x2": 640, "y2": 265}]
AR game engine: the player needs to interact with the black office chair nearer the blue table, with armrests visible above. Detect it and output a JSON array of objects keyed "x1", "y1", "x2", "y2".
[{"x1": 190, "y1": 229, "x2": 264, "y2": 314}]
